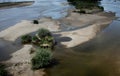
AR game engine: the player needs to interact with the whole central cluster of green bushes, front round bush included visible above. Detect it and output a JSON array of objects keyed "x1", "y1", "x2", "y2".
[{"x1": 21, "y1": 28, "x2": 54, "y2": 70}]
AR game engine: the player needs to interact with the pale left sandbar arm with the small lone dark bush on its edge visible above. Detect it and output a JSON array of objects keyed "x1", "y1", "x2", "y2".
[{"x1": 0, "y1": 18, "x2": 59, "y2": 41}]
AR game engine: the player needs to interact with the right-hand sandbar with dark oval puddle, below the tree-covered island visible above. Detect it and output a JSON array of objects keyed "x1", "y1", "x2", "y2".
[{"x1": 60, "y1": 12, "x2": 115, "y2": 48}]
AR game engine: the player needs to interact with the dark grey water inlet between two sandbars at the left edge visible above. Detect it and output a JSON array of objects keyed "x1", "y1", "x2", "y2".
[{"x1": 0, "y1": 39, "x2": 23, "y2": 62}]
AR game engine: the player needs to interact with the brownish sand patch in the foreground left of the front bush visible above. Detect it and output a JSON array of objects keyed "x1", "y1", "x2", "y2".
[{"x1": 5, "y1": 45, "x2": 45, "y2": 76}]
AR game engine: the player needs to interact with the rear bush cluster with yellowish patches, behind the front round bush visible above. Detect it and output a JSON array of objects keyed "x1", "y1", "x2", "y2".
[{"x1": 21, "y1": 28, "x2": 55, "y2": 49}]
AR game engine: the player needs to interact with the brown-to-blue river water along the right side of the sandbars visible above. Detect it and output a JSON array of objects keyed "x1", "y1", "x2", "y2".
[{"x1": 47, "y1": 0, "x2": 120, "y2": 76}]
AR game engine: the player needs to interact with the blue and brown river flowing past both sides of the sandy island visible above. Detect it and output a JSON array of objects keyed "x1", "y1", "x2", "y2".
[{"x1": 0, "y1": 0, "x2": 120, "y2": 76}]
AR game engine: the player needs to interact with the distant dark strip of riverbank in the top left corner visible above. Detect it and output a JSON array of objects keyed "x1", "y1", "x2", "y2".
[{"x1": 0, "y1": 1, "x2": 34, "y2": 9}]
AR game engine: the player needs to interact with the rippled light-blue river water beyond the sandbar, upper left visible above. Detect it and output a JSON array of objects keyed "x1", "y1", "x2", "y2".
[{"x1": 0, "y1": 0, "x2": 70, "y2": 31}]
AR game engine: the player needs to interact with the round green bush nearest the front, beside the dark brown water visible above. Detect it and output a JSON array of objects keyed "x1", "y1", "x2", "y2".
[{"x1": 31, "y1": 48, "x2": 53, "y2": 69}]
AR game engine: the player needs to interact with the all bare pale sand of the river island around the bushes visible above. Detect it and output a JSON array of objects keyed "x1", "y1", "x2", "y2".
[{"x1": 0, "y1": 8, "x2": 115, "y2": 76}]
